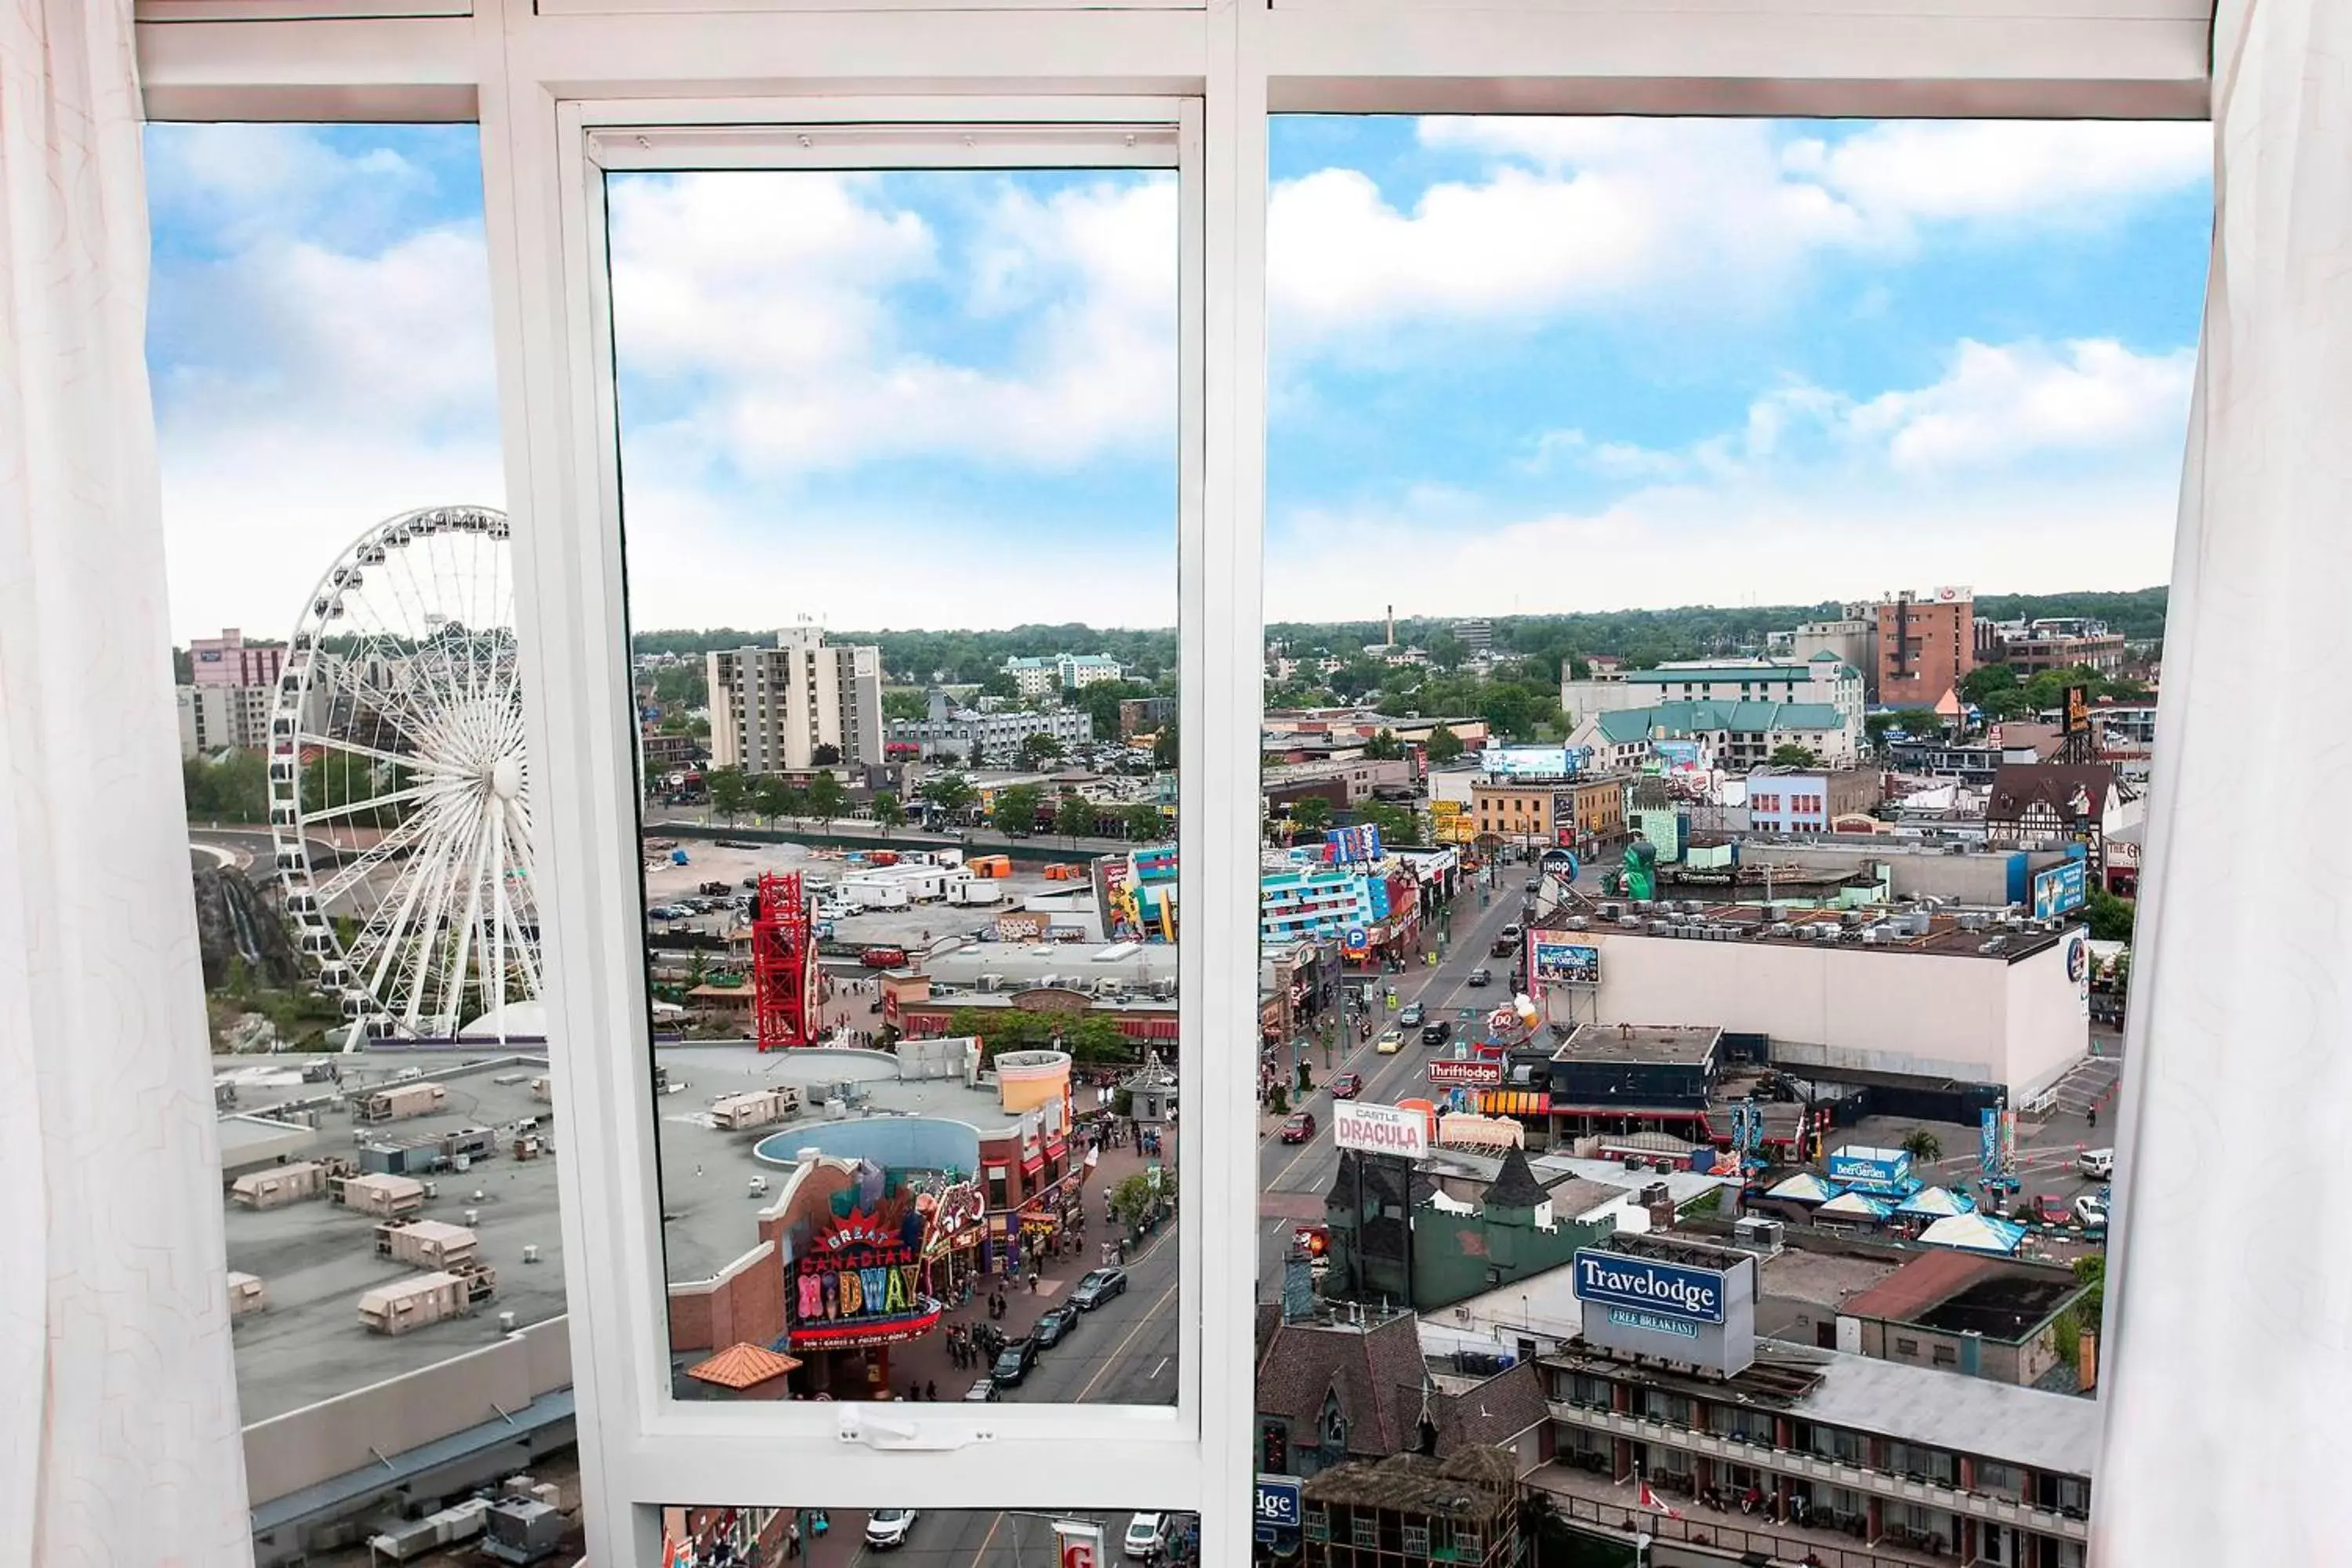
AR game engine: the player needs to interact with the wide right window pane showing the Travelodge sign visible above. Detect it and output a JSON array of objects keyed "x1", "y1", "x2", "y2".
[{"x1": 1256, "y1": 118, "x2": 2211, "y2": 1563}]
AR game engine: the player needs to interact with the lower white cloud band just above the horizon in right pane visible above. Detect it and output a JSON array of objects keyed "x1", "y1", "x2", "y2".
[{"x1": 1265, "y1": 341, "x2": 2194, "y2": 619}]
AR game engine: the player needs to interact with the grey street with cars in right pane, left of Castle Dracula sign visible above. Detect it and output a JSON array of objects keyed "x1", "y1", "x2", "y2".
[{"x1": 1258, "y1": 865, "x2": 1534, "y2": 1295}]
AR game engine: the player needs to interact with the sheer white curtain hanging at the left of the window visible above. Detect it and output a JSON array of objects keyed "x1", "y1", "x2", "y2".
[{"x1": 0, "y1": 0, "x2": 252, "y2": 1568}]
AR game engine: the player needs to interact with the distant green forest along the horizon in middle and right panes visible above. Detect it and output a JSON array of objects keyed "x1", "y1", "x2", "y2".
[{"x1": 635, "y1": 588, "x2": 2166, "y2": 684}]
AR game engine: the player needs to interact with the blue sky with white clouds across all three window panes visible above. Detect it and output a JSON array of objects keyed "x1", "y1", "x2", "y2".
[{"x1": 148, "y1": 118, "x2": 2211, "y2": 637}]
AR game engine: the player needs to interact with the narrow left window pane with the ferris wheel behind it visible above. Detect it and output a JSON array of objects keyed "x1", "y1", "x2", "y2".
[{"x1": 146, "y1": 125, "x2": 579, "y2": 1561}]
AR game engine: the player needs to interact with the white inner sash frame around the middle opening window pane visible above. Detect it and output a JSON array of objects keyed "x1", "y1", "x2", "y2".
[{"x1": 515, "y1": 94, "x2": 1223, "y2": 1512}]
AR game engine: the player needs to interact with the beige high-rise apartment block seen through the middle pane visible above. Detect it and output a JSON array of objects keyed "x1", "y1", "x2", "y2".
[{"x1": 703, "y1": 626, "x2": 882, "y2": 774}]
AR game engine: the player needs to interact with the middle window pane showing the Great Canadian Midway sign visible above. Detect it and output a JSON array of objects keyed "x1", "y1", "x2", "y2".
[{"x1": 607, "y1": 156, "x2": 1178, "y2": 1403}]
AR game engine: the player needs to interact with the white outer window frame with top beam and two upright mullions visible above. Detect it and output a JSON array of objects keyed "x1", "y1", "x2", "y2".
[{"x1": 139, "y1": 12, "x2": 2211, "y2": 1563}]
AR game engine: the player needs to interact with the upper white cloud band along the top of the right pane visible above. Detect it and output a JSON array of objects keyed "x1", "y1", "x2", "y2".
[{"x1": 1268, "y1": 118, "x2": 2211, "y2": 346}]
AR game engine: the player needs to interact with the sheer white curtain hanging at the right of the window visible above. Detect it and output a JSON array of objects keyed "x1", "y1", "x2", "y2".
[{"x1": 2091, "y1": 0, "x2": 2352, "y2": 1568}]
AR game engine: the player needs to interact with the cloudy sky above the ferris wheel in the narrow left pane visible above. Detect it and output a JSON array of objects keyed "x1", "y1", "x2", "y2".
[{"x1": 148, "y1": 125, "x2": 506, "y2": 640}]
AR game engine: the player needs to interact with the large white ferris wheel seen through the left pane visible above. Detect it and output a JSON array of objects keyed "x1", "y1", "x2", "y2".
[{"x1": 270, "y1": 506, "x2": 539, "y2": 1046}]
